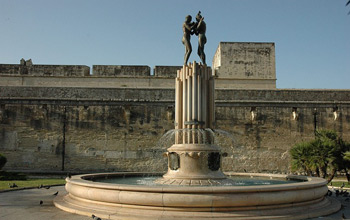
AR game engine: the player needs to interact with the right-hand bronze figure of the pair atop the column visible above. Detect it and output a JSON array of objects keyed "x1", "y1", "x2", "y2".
[{"x1": 194, "y1": 11, "x2": 207, "y2": 64}]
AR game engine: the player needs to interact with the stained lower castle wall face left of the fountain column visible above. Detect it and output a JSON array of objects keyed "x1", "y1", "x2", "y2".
[{"x1": 0, "y1": 105, "x2": 172, "y2": 171}]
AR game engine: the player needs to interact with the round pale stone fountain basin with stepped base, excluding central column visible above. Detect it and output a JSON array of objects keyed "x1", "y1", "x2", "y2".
[{"x1": 54, "y1": 173, "x2": 340, "y2": 219}]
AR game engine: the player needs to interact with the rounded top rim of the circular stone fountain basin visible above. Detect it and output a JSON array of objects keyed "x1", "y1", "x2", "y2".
[{"x1": 66, "y1": 172, "x2": 327, "y2": 193}]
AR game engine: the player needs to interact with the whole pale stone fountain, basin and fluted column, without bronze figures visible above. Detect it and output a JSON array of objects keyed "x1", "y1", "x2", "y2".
[{"x1": 54, "y1": 62, "x2": 340, "y2": 219}]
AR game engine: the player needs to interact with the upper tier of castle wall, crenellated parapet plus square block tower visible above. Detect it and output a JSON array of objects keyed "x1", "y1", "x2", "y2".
[{"x1": 0, "y1": 46, "x2": 276, "y2": 89}]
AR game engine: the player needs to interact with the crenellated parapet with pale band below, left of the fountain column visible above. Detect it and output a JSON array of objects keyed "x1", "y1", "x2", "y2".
[{"x1": 0, "y1": 64, "x2": 181, "y2": 88}]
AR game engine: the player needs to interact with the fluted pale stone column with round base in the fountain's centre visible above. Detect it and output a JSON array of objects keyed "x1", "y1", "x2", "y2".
[{"x1": 156, "y1": 62, "x2": 231, "y2": 185}]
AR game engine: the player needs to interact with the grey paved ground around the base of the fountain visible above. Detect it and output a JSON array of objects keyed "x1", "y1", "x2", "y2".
[{"x1": 0, "y1": 186, "x2": 350, "y2": 220}]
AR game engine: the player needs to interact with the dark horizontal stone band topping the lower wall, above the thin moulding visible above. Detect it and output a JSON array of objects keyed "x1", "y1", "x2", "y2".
[{"x1": 0, "y1": 86, "x2": 350, "y2": 102}]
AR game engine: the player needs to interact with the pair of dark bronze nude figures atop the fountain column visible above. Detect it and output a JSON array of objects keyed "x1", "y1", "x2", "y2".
[{"x1": 182, "y1": 11, "x2": 207, "y2": 65}]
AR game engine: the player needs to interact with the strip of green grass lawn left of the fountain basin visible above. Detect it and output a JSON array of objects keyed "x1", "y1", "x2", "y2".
[{"x1": 0, "y1": 179, "x2": 66, "y2": 190}]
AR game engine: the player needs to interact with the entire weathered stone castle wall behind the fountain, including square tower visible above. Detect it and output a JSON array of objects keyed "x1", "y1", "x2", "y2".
[{"x1": 0, "y1": 42, "x2": 350, "y2": 173}]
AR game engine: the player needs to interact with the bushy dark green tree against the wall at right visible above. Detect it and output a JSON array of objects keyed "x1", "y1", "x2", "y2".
[{"x1": 290, "y1": 130, "x2": 350, "y2": 182}]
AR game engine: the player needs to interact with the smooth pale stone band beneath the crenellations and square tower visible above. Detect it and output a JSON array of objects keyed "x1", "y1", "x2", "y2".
[{"x1": 0, "y1": 69, "x2": 275, "y2": 89}]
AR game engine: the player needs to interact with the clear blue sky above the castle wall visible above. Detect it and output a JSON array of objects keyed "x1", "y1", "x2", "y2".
[{"x1": 0, "y1": 0, "x2": 350, "y2": 89}]
